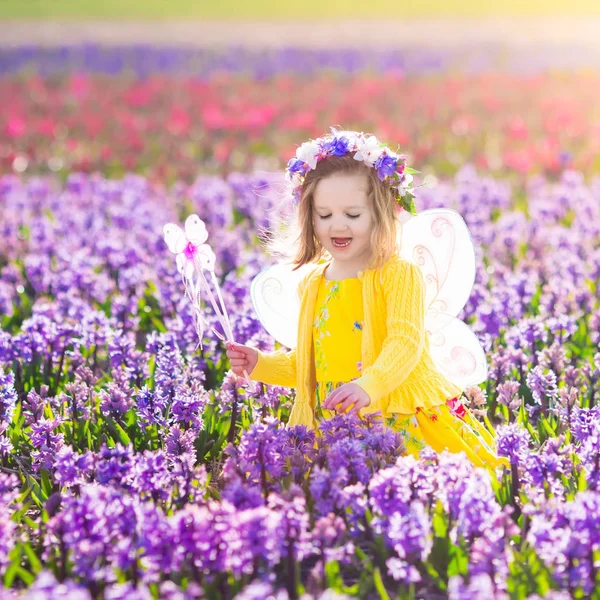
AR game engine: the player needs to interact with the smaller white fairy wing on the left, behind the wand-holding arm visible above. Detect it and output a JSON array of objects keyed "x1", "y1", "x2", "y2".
[{"x1": 250, "y1": 263, "x2": 311, "y2": 348}]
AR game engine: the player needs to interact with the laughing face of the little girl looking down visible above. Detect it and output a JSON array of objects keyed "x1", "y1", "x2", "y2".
[{"x1": 313, "y1": 173, "x2": 374, "y2": 271}]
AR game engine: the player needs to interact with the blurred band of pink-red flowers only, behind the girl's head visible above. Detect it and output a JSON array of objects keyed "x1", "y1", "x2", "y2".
[{"x1": 0, "y1": 71, "x2": 600, "y2": 178}]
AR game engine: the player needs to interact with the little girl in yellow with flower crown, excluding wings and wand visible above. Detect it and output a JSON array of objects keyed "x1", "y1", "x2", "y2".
[{"x1": 227, "y1": 130, "x2": 506, "y2": 474}]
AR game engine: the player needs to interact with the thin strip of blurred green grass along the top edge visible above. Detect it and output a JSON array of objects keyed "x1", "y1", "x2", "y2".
[{"x1": 0, "y1": 0, "x2": 600, "y2": 21}]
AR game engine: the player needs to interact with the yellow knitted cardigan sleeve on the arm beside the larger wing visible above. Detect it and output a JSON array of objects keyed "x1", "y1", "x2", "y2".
[{"x1": 354, "y1": 261, "x2": 425, "y2": 410}]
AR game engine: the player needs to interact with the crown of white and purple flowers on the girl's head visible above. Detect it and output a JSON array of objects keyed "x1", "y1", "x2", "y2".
[{"x1": 285, "y1": 127, "x2": 420, "y2": 215}]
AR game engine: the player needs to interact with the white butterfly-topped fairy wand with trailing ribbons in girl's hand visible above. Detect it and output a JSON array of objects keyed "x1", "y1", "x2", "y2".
[{"x1": 163, "y1": 215, "x2": 252, "y2": 385}]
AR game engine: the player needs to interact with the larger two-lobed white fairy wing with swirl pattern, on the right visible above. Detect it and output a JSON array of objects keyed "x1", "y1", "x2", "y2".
[{"x1": 398, "y1": 208, "x2": 488, "y2": 389}]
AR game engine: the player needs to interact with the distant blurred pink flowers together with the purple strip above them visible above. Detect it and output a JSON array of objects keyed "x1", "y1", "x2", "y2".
[{"x1": 0, "y1": 48, "x2": 600, "y2": 182}]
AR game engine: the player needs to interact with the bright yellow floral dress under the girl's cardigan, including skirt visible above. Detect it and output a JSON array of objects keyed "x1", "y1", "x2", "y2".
[{"x1": 313, "y1": 276, "x2": 507, "y2": 468}]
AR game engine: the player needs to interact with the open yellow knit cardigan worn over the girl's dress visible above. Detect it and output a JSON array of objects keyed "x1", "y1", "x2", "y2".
[{"x1": 250, "y1": 255, "x2": 462, "y2": 429}]
